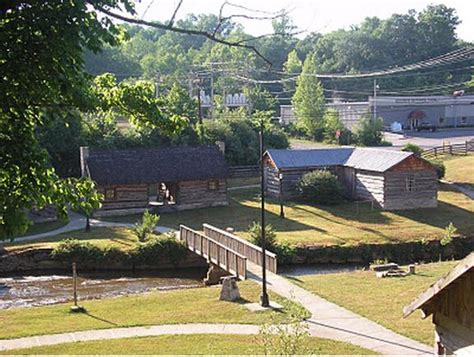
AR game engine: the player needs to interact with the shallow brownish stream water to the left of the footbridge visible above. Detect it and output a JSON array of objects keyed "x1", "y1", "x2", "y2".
[{"x1": 0, "y1": 269, "x2": 205, "y2": 309}]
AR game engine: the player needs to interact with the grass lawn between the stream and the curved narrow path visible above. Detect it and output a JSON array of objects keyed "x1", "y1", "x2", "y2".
[{"x1": 0, "y1": 281, "x2": 308, "y2": 339}]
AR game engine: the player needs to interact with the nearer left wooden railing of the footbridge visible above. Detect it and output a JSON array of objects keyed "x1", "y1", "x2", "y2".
[{"x1": 179, "y1": 225, "x2": 247, "y2": 280}]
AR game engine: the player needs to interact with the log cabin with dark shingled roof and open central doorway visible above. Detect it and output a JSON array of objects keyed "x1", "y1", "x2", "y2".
[{"x1": 81, "y1": 146, "x2": 228, "y2": 216}]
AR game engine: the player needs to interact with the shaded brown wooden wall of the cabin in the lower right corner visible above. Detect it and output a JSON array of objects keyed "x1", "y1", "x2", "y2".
[{"x1": 433, "y1": 268, "x2": 474, "y2": 355}]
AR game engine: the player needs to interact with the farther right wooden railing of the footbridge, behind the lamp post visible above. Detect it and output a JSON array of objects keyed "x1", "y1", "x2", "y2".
[{"x1": 203, "y1": 224, "x2": 277, "y2": 273}]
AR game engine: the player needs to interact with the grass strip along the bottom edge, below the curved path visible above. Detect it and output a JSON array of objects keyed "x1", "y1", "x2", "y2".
[{"x1": 0, "y1": 335, "x2": 375, "y2": 355}]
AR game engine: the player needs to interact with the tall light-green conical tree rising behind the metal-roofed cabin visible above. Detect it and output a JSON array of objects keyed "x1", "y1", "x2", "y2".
[{"x1": 292, "y1": 54, "x2": 326, "y2": 140}]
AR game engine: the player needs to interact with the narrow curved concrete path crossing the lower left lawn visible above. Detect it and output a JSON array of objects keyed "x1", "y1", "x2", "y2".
[{"x1": 0, "y1": 324, "x2": 259, "y2": 351}]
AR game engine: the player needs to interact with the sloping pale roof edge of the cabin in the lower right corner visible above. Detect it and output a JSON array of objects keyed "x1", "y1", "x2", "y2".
[{"x1": 403, "y1": 253, "x2": 474, "y2": 317}]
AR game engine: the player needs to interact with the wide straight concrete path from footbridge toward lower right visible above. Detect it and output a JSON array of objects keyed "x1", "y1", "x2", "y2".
[{"x1": 247, "y1": 262, "x2": 432, "y2": 355}]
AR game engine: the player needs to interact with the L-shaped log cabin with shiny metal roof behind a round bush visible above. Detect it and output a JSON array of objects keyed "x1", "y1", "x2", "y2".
[{"x1": 264, "y1": 147, "x2": 438, "y2": 210}]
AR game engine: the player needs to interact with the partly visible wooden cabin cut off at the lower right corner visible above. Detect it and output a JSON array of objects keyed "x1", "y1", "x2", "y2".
[{"x1": 403, "y1": 253, "x2": 474, "y2": 356}]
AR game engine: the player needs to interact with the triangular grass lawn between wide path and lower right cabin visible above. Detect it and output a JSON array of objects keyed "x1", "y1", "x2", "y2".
[{"x1": 290, "y1": 262, "x2": 457, "y2": 345}]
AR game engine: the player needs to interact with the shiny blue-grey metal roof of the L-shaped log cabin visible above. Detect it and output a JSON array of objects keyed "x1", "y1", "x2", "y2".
[{"x1": 266, "y1": 147, "x2": 413, "y2": 172}]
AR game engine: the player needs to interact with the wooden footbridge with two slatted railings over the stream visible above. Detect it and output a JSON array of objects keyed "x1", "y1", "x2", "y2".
[{"x1": 179, "y1": 224, "x2": 277, "y2": 280}]
